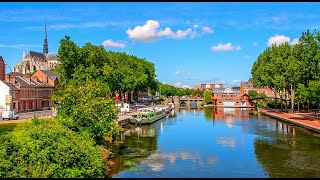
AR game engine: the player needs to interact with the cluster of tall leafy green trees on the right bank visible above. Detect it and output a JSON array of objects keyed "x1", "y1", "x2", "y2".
[{"x1": 251, "y1": 30, "x2": 320, "y2": 111}]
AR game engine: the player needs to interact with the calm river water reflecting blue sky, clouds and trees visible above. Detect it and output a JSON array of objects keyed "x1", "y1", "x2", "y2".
[{"x1": 111, "y1": 108, "x2": 320, "y2": 178}]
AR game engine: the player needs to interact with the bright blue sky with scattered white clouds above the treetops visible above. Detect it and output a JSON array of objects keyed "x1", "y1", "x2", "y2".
[{"x1": 0, "y1": 2, "x2": 320, "y2": 87}]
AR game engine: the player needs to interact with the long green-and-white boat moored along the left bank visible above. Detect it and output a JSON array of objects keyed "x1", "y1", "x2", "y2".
[{"x1": 130, "y1": 108, "x2": 170, "y2": 125}]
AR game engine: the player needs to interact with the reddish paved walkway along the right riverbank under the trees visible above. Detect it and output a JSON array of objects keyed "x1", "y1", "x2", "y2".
[{"x1": 259, "y1": 109, "x2": 320, "y2": 133}]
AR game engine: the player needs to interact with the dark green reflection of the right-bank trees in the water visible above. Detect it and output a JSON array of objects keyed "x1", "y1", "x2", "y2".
[{"x1": 254, "y1": 122, "x2": 320, "y2": 178}]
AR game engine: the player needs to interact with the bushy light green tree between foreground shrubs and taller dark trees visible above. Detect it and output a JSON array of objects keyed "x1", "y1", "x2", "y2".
[{"x1": 53, "y1": 81, "x2": 118, "y2": 144}]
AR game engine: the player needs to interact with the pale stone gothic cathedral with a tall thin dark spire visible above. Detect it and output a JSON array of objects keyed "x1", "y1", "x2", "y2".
[{"x1": 14, "y1": 22, "x2": 59, "y2": 74}]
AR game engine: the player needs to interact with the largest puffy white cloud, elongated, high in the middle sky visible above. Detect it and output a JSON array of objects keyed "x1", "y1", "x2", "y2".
[{"x1": 126, "y1": 20, "x2": 198, "y2": 42}]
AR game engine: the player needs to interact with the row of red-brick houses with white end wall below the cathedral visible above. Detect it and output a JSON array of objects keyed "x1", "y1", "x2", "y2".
[{"x1": 0, "y1": 56, "x2": 59, "y2": 112}]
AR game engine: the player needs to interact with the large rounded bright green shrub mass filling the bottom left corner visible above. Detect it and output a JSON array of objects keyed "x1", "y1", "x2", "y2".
[{"x1": 0, "y1": 118, "x2": 105, "y2": 178}]
